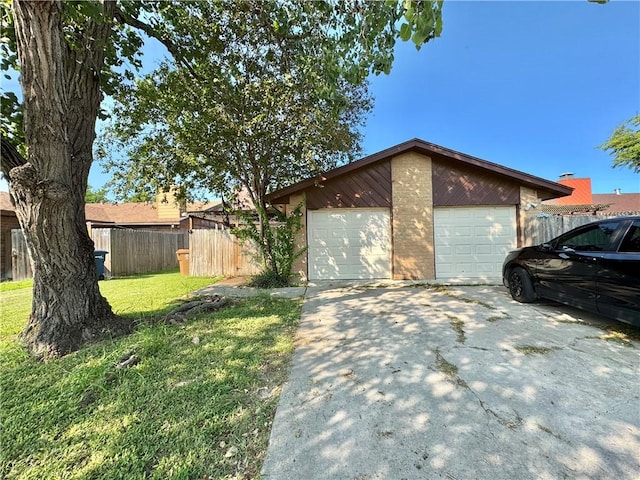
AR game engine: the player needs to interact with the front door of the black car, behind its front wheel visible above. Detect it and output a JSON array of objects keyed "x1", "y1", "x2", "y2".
[{"x1": 536, "y1": 221, "x2": 618, "y2": 310}]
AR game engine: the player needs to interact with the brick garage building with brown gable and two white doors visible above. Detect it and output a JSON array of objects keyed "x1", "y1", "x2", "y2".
[{"x1": 268, "y1": 139, "x2": 572, "y2": 281}]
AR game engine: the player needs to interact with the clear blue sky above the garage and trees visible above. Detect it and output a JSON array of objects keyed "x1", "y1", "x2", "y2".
[{"x1": 0, "y1": 0, "x2": 640, "y2": 193}]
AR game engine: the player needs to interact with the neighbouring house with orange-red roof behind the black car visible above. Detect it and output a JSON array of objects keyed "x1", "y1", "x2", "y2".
[{"x1": 537, "y1": 173, "x2": 640, "y2": 215}]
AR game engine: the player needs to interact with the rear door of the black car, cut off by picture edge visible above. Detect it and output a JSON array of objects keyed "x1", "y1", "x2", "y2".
[{"x1": 596, "y1": 220, "x2": 640, "y2": 326}]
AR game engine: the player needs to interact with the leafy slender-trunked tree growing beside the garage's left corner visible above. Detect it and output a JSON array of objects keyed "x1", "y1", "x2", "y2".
[{"x1": 99, "y1": 1, "x2": 441, "y2": 280}]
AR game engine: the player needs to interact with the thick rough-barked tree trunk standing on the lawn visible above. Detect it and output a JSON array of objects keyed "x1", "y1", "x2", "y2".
[{"x1": 9, "y1": 0, "x2": 131, "y2": 357}]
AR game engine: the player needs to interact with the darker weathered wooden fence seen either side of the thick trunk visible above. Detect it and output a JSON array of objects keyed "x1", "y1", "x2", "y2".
[{"x1": 11, "y1": 228, "x2": 189, "y2": 281}]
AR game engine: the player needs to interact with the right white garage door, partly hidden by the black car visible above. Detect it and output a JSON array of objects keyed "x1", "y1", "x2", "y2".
[{"x1": 434, "y1": 207, "x2": 516, "y2": 281}]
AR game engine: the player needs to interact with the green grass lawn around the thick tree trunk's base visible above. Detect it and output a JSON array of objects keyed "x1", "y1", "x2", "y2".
[{"x1": 0, "y1": 272, "x2": 300, "y2": 479}]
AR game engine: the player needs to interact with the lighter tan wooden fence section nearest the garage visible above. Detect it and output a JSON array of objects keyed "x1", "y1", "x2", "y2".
[{"x1": 189, "y1": 229, "x2": 260, "y2": 277}]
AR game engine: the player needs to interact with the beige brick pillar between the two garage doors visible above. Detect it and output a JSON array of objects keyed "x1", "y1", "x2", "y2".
[{"x1": 391, "y1": 152, "x2": 435, "y2": 280}]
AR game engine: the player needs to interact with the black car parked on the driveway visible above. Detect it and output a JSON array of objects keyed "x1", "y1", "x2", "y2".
[{"x1": 502, "y1": 217, "x2": 640, "y2": 326}]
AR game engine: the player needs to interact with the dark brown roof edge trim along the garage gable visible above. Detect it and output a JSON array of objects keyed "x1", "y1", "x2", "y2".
[{"x1": 266, "y1": 138, "x2": 573, "y2": 205}]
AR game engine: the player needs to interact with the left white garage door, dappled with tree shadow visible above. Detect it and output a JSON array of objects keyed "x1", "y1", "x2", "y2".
[{"x1": 307, "y1": 208, "x2": 391, "y2": 280}]
